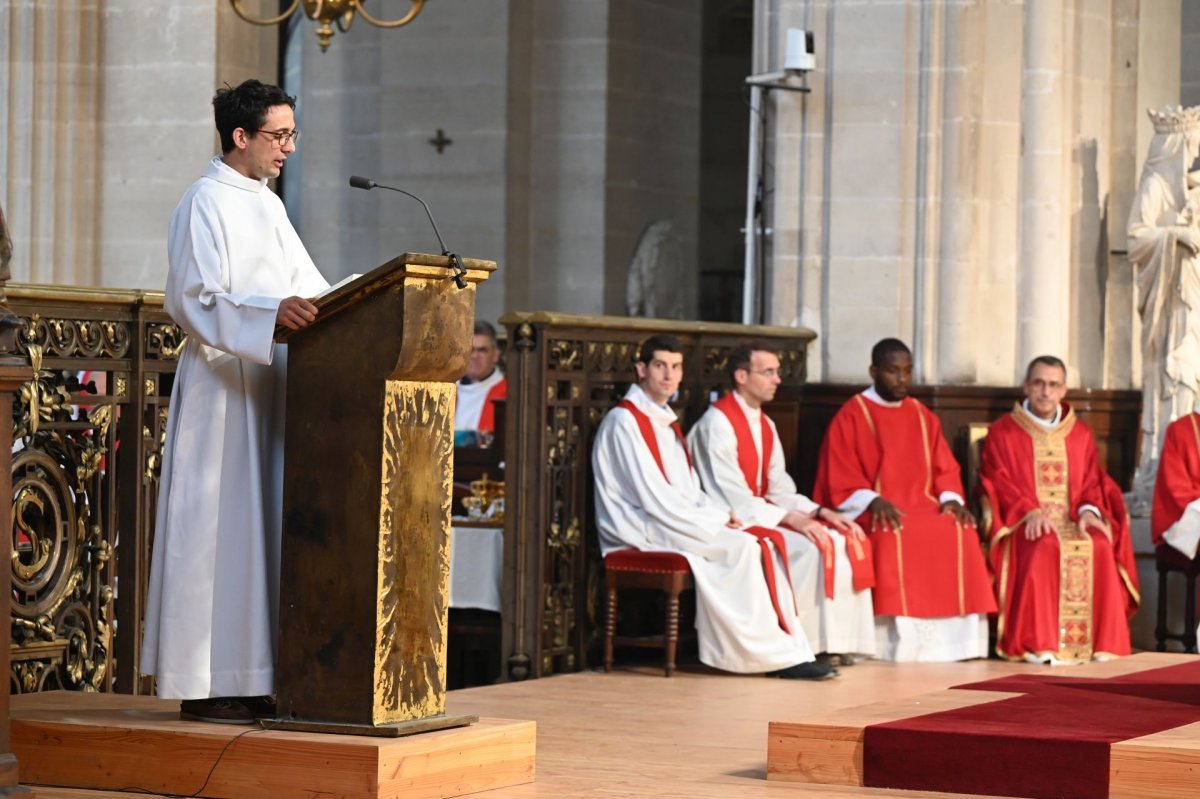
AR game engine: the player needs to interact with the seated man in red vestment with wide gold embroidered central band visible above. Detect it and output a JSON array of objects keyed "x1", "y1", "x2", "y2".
[{"x1": 979, "y1": 355, "x2": 1140, "y2": 663}]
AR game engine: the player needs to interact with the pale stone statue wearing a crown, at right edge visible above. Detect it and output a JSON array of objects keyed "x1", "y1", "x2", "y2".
[{"x1": 1127, "y1": 107, "x2": 1200, "y2": 516}]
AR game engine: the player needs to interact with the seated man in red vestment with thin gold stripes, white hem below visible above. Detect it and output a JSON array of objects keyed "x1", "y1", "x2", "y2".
[{"x1": 812, "y1": 338, "x2": 996, "y2": 661}]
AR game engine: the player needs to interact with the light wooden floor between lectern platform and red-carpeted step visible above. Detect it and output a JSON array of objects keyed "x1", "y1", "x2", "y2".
[{"x1": 17, "y1": 655, "x2": 1194, "y2": 799}]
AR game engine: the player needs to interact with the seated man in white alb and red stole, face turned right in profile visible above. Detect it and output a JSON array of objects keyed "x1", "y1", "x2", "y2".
[{"x1": 688, "y1": 342, "x2": 875, "y2": 665}]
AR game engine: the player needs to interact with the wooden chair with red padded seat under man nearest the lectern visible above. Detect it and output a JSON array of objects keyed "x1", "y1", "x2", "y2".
[{"x1": 604, "y1": 549, "x2": 695, "y2": 677}]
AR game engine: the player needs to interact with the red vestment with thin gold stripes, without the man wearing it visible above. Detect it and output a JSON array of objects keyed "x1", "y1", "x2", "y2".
[{"x1": 812, "y1": 395, "x2": 996, "y2": 618}]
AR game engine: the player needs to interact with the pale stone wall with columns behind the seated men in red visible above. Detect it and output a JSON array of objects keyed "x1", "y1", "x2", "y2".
[{"x1": 756, "y1": 0, "x2": 1181, "y2": 388}]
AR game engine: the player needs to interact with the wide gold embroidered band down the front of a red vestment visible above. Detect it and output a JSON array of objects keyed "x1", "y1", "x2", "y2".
[{"x1": 1006, "y1": 403, "x2": 1096, "y2": 662}]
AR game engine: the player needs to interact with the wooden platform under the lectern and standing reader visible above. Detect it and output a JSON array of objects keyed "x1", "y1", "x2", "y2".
[{"x1": 12, "y1": 692, "x2": 536, "y2": 799}]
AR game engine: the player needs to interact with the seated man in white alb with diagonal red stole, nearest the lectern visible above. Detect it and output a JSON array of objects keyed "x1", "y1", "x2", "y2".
[{"x1": 592, "y1": 335, "x2": 836, "y2": 679}]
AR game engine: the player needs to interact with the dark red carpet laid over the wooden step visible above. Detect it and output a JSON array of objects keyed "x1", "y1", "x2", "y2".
[{"x1": 863, "y1": 662, "x2": 1200, "y2": 799}]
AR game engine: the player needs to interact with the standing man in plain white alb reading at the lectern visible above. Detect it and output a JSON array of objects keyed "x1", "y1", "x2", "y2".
[{"x1": 142, "y1": 80, "x2": 329, "y2": 723}]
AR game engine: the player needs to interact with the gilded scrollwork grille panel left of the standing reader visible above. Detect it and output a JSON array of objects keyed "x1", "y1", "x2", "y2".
[{"x1": 10, "y1": 347, "x2": 113, "y2": 691}]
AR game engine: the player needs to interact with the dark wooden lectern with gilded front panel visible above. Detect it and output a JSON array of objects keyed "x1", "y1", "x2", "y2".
[{"x1": 271, "y1": 253, "x2": 496, "y2": 735}]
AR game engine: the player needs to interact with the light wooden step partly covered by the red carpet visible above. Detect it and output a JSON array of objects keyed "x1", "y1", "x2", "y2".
[{"x1": 767, "y1": 653, "x2": 1200, "y2": 799}]
